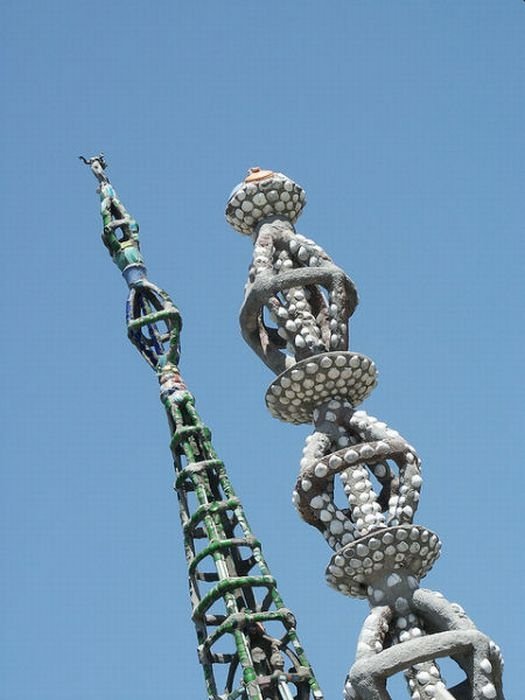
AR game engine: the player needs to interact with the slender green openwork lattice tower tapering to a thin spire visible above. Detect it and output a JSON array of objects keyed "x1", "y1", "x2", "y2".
[{"x1": 81, "y1": 154, "x2": 323, "y2": 700}]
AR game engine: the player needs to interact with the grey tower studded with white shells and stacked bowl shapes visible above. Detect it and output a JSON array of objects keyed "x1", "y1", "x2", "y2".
[{"x1": 226, "y1": 168, "x2": 503, "y2": 700}]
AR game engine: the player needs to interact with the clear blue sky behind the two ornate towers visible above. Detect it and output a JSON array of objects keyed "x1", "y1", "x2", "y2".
[{"x1": 0, "y1": 0, "x2": 525, "y2": 700}]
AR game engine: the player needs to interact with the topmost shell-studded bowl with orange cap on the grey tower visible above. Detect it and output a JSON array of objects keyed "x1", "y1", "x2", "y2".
[{"x1": 226, "y1": 168, "x2": 306, "y2": 236}]
